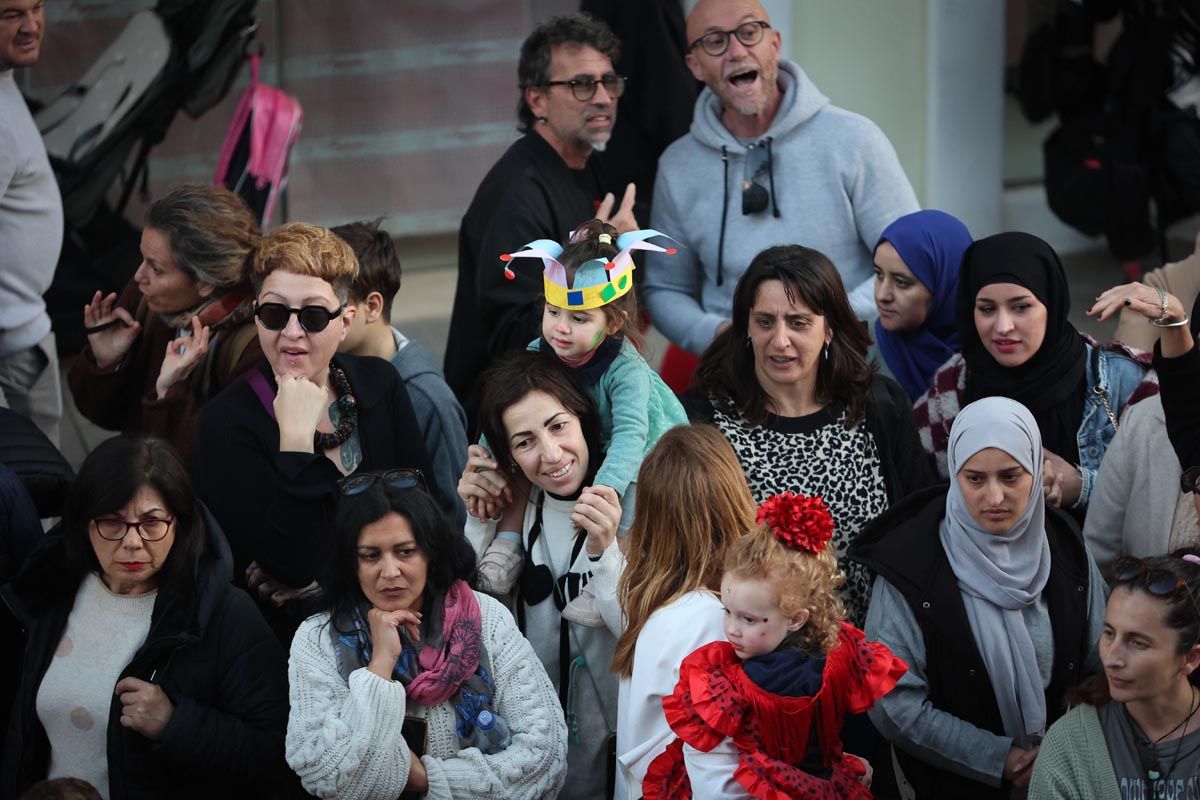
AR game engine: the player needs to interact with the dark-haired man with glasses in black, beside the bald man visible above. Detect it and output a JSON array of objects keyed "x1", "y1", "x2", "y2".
[{"x1": 445, "y1": 14, "x2": 637, "y2": 425}]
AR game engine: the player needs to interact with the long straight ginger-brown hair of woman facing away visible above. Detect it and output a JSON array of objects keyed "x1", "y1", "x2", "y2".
[{"x1": 612, "y1": 425, "x2": 755, "y2": 678}]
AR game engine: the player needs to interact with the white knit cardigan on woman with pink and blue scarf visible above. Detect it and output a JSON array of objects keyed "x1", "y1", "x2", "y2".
[{"x1": 287, "y1": 593, "x2": 566, "y2": 800}]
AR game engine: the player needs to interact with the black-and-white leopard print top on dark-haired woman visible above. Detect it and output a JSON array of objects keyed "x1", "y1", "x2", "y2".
[{"x1": 713, "y1": 401, "x2": 888, "y2": 627}]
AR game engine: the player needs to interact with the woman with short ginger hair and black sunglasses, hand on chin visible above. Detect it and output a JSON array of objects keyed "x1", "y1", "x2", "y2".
[{"x1": 197, "y1": 223, "x2": 457, "y2": 634}]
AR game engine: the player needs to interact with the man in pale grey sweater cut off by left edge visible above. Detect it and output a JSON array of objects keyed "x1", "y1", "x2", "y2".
[{"x1": 0, "y1": 0, "x2": 62, "y2": 445}]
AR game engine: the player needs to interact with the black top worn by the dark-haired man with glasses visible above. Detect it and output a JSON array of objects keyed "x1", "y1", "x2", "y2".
[{"x1": 444, "y1": 133, "x2": 604, "y2": 426}]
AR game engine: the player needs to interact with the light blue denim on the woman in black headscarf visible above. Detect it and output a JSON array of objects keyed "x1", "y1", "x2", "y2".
[{"x1": 1072, "y1": 342, "x2": 1147, "y2": 509}]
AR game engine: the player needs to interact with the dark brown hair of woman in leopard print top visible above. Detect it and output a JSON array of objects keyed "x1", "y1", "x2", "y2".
[{"x1": 696, "y1": 245, "x2": 875, "y2": 427}]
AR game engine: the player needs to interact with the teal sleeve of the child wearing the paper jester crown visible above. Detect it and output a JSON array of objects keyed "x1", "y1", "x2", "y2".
[{"x1": 595, "y1": 355, "x2": 650, "y2": 498}]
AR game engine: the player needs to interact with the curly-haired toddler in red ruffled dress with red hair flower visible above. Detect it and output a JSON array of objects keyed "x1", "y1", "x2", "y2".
[{"x1": 642, "y1": 492, "x2": 908, "y2": 800}]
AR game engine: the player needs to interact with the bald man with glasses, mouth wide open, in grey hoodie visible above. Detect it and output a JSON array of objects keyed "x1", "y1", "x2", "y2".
[{"x1": 643, "y1": 0, "x2": 919, "y2": 354}]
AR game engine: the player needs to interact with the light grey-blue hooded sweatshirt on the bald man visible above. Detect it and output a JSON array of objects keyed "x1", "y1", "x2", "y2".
[{"x1": 643, "y1": 60, "x2": 920, "y2": 354}]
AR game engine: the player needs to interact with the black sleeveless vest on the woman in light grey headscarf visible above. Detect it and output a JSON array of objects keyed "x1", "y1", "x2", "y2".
[{"x1": 847, "y1": 485, "x2": 1092, "y2": 800}]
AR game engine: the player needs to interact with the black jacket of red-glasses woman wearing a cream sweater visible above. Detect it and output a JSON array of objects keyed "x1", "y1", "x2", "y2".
[{"x1": 0, "y1": 515, "x2": 295, "y2": 800}]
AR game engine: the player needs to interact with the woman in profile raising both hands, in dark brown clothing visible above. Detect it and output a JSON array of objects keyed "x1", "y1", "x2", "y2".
[{"x1": 67, "y1": 184, "x2": 263, "y2": 463}]
